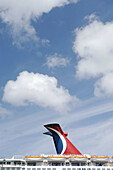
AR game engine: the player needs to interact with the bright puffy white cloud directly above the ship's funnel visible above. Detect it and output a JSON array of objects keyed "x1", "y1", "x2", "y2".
[{"x1": 3, "y1": 71, "x2": 77, "y2": 112}]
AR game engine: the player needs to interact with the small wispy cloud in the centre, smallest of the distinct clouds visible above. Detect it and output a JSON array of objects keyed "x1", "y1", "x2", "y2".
[{"x1": 46, "y1": 53, "x2": 69, "y2": 68}]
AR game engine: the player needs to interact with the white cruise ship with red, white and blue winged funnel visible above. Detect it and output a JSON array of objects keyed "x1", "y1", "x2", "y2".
[{"x1": 0, "y1": 123, "x2": 113, "y2": 170}]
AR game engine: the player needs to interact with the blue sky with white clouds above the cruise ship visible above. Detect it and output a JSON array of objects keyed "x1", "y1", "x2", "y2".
[{"x1": 0, "y1": 0, "x2": 113, "y2": 157}]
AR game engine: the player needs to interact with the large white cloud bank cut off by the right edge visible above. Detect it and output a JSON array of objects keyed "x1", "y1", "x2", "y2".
[{"x1": 73, "y1": 15, "x2": 113, "y2": 96}]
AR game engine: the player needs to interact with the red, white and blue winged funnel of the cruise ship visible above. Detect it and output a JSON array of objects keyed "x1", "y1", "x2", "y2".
[{"x1": 44, "y1": 123, "x2": 82, "y2": 155}]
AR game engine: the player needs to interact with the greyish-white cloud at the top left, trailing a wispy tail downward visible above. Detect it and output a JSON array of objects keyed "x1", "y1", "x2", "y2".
[{"x1": 0, "y1": 0, "x2": 77, "y2": 44}]
